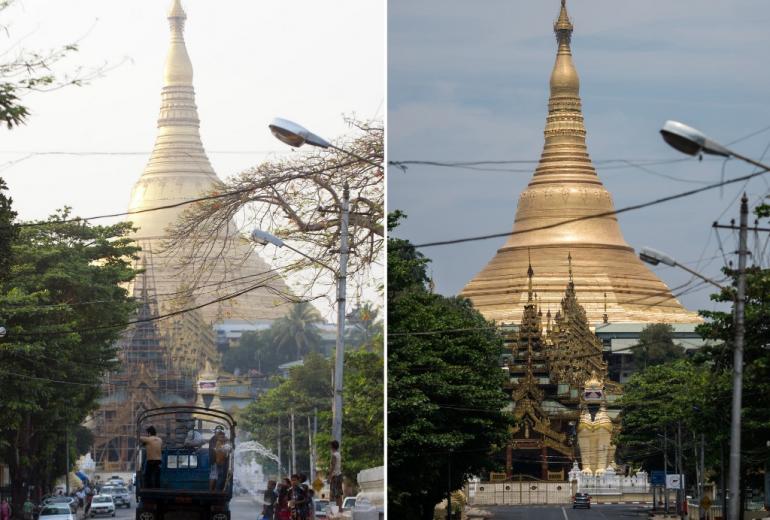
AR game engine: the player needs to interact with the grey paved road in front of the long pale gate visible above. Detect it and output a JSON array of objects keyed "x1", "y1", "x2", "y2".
[{"x1": 482, "y1": 504, "x2": 649, "y2": 520}]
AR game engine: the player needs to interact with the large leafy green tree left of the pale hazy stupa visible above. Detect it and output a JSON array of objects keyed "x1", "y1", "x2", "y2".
[{"x1": 0, "y1": 210, "x2": 137, "y2": 503}]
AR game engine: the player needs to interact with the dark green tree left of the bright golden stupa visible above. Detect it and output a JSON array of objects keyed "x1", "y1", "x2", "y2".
[{"x1": 388, "y1": 214, "x2": 511, "y2": 520}]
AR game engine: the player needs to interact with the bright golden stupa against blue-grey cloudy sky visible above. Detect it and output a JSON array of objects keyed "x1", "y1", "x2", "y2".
[{"x1": 461, "y1": 0, "x2": 701, "y2": 323}]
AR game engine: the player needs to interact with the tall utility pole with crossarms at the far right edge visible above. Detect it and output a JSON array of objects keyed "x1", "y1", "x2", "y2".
[{"x1": 728, "y1": 193, "x2": 749, "y2": 520}]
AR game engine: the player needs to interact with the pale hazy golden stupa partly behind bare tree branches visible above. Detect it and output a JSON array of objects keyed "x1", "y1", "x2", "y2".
[{"x1": 129, "y1": 0, "x2": 290, "y2": 324}]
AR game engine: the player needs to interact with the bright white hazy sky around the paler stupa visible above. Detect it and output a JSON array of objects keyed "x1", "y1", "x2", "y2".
[{"x1": 0, "y1": 0, "x2": 385, "y2": 318}]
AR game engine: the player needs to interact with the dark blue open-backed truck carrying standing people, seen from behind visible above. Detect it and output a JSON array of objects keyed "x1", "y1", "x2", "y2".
[{"x1": 135, "y1": 406, "x2": 236, "y2": 520}]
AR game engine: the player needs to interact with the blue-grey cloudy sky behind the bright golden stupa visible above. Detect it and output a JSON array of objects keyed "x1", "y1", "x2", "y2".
[{"x1": 388, "y1": 0, "x2": 770, "y2": 309}]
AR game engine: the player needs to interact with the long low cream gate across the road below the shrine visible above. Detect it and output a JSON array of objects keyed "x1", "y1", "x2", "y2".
[{"x1": 467, "y1": 481, "x2": 572, "y2": 506}]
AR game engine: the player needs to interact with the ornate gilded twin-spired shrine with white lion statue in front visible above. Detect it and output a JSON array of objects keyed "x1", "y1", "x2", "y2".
[{"x1": 503, "y1": 256, "x2": 620, "y2": 481}]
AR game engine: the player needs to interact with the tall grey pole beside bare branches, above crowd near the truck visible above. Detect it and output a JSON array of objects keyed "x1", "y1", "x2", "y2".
[{"x1": 332, "y1": 181, "x2": 350, "y2": 449}]
